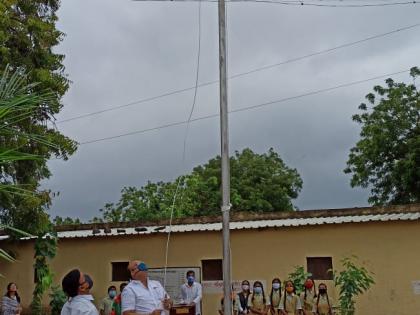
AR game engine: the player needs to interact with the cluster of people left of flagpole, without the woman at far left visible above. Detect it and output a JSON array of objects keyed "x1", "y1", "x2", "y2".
[{"x1": 61, "y1": 260, "x2": 202, "y2": 315}]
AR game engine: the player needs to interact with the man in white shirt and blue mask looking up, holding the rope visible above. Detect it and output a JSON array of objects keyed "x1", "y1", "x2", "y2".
[{"x1": 121, "y1": 260, "x2": 172, "y2": 315}]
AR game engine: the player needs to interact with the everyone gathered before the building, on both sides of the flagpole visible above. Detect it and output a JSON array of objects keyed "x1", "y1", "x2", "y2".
[{"x1": 1, "y1": 261, "x2": 334, "y2": 315}]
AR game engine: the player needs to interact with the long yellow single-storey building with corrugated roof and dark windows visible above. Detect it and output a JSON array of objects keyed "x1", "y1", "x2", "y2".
[{"x1": 0, "y1": 204, "x2": 420, "y2": 315}]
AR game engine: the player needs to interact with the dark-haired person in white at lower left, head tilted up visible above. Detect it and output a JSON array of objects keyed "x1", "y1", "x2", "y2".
[{"x1": 61, "y1": 269, "x2": 99, "y2": 315}]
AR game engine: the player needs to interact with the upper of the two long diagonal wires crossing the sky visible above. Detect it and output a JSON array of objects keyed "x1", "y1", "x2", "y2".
[{"x1": 57, "y1": 22, "x2": 420, "y2": 124}]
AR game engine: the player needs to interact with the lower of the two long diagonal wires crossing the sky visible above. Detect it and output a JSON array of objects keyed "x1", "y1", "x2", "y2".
[{"x1": 79, "y1": 70, "x2": 410, "y2": 145}]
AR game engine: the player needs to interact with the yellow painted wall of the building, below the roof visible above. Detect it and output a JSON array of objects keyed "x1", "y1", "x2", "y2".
[{"x1": 0, "y1": 221, "x2": 420, "y2": 315}]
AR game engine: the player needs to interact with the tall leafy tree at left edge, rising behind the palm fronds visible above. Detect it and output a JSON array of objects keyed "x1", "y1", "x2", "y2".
[{"x1": 0, "y1": 0, "x2": 76, "y2": 234}]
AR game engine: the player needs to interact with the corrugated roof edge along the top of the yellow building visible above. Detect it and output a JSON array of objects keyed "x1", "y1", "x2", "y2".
[{"x1": 0, "y1": 204, "x2": 420, "y2": 240}]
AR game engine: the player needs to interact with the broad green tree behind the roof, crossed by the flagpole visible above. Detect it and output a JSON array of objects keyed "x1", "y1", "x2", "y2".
[{"x1": 98, "y1": 149, "x2": 302, "y2": 222}]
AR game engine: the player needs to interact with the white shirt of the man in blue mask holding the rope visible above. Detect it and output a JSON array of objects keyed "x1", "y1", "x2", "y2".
[{"x1": 121, "y1": 279, "x2": 169, "y2": 315}]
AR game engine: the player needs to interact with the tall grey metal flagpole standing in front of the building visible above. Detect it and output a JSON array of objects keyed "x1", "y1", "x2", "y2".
[{"x1": 219, "y1": 0, "x2": 232, "y2": 315}]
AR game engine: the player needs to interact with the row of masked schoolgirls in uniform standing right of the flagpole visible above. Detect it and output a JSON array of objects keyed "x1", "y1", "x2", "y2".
[{"x1": 228, "y1": 278, "x2": 334, "y2": 315}]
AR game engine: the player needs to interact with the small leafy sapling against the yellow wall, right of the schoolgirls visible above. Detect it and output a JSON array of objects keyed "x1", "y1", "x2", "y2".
[{"x1": 334, "y1": 256, "x2": 375, "y2": 315}]
